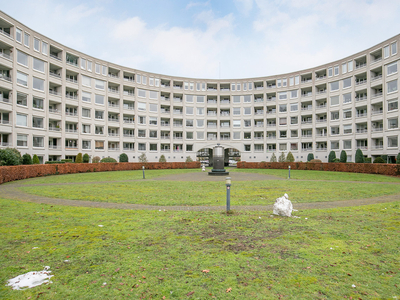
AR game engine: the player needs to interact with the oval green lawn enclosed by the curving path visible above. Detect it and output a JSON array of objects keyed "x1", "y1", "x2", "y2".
[{"x1": 19, "y1": 180, "x2": 400, "y2": 206}]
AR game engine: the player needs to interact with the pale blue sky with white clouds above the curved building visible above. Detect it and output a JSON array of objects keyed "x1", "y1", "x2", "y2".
[{"x1": 0, "y1": 0, "x2": 400, "y2": 79}]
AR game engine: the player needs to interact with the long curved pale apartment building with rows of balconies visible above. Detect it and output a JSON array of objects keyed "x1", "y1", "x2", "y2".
[{"x1": 0, "y1": 11, "x2": 400, "y2": 162}]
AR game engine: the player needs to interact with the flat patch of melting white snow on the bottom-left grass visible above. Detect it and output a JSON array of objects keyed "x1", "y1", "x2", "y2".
[{"x1": 7, "y1": 266, "x2": 54, "y2": 290}]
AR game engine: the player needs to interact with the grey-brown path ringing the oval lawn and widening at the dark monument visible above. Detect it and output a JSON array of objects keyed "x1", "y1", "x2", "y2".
[{"x1": 0, "y1": 172, "x2": 400, "y2": 211}]
